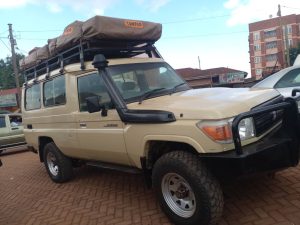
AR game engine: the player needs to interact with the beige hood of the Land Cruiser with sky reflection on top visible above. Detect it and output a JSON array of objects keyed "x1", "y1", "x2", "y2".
[{"x1": 128, "y1": 88, "x2": 279, "y2": 119}]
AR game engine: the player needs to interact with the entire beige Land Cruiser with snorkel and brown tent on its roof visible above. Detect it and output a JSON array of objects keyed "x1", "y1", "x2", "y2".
[{"x1": 21, "y1": 17, "x2": 299, "y2": 224}]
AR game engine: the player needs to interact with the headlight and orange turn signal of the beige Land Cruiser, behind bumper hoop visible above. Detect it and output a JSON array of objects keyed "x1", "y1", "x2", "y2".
[{"x1": 197, "y1": 117, "x2": 255, "y2": 143}]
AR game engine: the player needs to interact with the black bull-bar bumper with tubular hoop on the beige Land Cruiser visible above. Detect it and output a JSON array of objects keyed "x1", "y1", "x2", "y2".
[{"x1": 200, "y1": 100, "x2": 300, "y2": 176}]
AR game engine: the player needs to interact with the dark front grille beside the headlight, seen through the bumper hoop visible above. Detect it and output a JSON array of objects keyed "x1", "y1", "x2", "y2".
[{"x1": 253, "y1": 110, "x2": 284, "y2": 137}]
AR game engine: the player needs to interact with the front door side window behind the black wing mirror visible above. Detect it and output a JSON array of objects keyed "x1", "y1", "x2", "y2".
[{"x1": 77, "y1": 73, "x2": 113, "y2": 111}]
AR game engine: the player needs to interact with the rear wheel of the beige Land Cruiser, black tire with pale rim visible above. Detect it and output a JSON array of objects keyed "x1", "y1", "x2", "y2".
[{"x1": 43, "y1": 142, "x2": 73, "y2": 183}]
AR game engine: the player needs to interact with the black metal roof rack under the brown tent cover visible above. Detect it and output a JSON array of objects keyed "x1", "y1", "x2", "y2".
[{"x1": 23, "y1": 41, "x2": 162, "y2": 83}]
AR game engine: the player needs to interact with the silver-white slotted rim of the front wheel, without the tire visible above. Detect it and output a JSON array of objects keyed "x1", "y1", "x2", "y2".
[{"x1": 161, "y1": 173, "x2": 196, "y2": 218}]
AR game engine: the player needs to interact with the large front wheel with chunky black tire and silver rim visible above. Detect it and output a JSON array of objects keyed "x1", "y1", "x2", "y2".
[{"x1": 152, "y1": 151, "x2": 224, "y2": 225}]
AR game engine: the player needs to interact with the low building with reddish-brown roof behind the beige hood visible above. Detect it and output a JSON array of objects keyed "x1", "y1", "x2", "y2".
[{"x1": 176, "y1": 67, "x2": 247, "y2": 88}]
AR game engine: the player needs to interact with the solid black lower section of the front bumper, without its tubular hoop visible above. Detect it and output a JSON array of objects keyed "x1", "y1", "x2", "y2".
[{"x1": 199, "y1": 124, "x2": 299, "y2": 177}]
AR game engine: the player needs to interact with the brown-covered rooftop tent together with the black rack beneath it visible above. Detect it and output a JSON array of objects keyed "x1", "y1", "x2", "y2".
[{"x1": 20, "y1": 16, "x2": 162, "y2": 76}]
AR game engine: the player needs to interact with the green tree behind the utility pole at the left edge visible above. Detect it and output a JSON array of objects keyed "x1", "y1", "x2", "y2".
[{"x1": 0, "y1": 54, "x2": 24, "y2": 89}]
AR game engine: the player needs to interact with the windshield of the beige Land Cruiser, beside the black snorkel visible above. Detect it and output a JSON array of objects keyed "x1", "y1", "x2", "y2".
[{"x1": 108, "y1": 63, "x2": 189, "y2": 102}]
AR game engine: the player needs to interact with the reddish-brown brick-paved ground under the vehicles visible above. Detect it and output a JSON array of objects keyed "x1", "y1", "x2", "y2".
[{"x1": 0, "y1": 149, "x2": 300, "y2": 225}]
